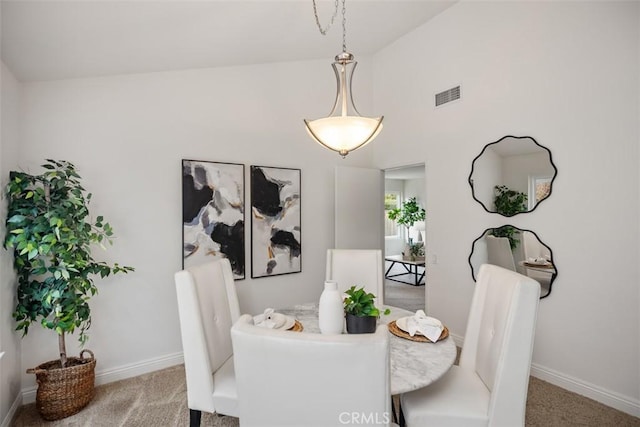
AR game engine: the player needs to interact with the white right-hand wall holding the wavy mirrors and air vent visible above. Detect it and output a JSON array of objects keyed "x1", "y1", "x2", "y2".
[{"x1": 374, "y1": 2, "x2": 640, "y2": 416}]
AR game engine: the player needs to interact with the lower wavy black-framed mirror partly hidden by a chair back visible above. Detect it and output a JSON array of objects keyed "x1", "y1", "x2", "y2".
[{"x1": 469, "y1": 225, "x2": 558, "y2": 299}]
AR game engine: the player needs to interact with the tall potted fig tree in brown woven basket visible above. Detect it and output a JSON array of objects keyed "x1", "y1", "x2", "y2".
[{"x1": 4, "y1": 159, "x2": 133, "y2": 420}]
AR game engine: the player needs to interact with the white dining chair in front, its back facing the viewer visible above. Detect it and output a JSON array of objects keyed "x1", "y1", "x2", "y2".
[{"x1": 231, "y1": 315, "x2": 392, "y2": 427}]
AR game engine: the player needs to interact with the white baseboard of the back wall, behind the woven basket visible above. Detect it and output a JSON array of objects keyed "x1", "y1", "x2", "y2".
[{"x1": 22, "y1": 353, "x2": 184, "y2": 404}]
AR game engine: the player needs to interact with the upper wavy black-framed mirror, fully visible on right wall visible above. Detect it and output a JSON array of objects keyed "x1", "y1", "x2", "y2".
[{"x1": 469, "y1": 135, "x2": 558, "y2": 217}]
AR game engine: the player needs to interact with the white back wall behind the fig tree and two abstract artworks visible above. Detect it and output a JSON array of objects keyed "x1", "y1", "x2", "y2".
[{"x1": 15, "y1": 59, "x2": 375, "y2": 394}]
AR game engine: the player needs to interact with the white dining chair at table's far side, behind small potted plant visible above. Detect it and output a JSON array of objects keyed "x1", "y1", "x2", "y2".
[{"x1": 325, "y1": 249, "x2": 384, "y2": 306}]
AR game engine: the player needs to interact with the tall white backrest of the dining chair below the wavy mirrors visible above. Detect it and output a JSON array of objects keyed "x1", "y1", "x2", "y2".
[{"x1": 460, "y1": 264, "x2": 540, "y2": 426}]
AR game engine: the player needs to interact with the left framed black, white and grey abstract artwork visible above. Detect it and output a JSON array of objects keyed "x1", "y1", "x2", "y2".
[{"x1": 182, "y1": 159, "x2": 245, "y2": 280}]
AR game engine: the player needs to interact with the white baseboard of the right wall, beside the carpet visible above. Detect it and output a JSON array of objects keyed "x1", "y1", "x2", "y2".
[{"x1": 531, "y1": 363, "x2": 640, "y2": 417}]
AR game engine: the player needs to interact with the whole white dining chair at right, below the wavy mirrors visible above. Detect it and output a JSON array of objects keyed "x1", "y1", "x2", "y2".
[{"x1": 400, "y1": 264, "x2": 540, "y2": 427}]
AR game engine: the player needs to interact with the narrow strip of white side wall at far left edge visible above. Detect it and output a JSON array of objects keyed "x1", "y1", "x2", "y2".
[{"x1": 0, "y1": 63, "x2": 22, "y2": 425}]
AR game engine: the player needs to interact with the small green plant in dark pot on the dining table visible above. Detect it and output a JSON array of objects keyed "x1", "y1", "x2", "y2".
[{"x1": 343, "y1": 286, "x2": 391, "y2": 334}]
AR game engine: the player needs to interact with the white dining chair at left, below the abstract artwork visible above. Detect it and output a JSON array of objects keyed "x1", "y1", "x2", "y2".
[{"x1": 175, "y1": 258, "x2": 240, "y2": 427}]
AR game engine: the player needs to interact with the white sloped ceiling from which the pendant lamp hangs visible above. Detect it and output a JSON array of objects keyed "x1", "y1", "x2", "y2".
[{"x1": 0, "y1": 0, "x2": 455, "y2": 82}]
